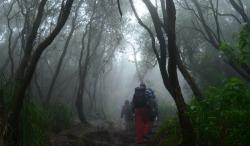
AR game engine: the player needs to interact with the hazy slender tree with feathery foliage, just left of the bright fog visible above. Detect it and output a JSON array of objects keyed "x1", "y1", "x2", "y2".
[{"x1": 75, "y1": 1, "x2": 120, "y2": 124}]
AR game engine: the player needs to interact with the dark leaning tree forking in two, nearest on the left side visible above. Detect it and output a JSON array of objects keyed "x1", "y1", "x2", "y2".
[{"x1": 5, "y1": 0, "x2": 74, "y2": 145}]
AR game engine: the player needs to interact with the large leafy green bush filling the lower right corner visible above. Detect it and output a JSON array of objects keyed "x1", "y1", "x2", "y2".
[{"x1": 189, "y1": 79, "x2": 250, "y2": 146}]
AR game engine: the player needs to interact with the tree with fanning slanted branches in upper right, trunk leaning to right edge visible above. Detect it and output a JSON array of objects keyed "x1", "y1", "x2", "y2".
[{"x1": 179, "y1": 0, "x2": 250, "y2": 82}]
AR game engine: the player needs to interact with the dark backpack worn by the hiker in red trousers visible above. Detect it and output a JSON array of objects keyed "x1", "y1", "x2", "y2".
[{"x1": 133, "y1": 87, "x2": 147, "y2": 108}]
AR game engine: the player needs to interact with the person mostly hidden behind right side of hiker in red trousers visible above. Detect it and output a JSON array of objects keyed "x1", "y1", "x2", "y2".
[{"x1": 145, "y1": 88, "x2": 158, "y2": 134}]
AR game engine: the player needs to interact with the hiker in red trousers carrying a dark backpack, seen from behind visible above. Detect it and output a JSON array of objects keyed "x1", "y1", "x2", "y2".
[{"x1": 132, "y1": 83, "x2": 150, "y2": 144}]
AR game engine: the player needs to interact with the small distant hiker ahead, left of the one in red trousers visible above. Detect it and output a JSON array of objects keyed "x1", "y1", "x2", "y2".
[{"x1": 121, "y1": 100, "x2": 133, "y2": 130}]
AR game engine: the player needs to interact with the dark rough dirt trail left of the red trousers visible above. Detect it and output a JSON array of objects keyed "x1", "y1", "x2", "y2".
[{"x1": 50, "y1": 121, "x2": 147, "y2": 146}]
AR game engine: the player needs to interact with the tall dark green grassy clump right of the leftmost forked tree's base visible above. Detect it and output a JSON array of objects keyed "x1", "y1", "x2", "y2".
[{"x1": 20, "y1": 99, "x2": 50, "y2": 146}]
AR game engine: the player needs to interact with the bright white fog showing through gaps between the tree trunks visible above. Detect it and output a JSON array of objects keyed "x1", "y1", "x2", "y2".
[{"x1": 0, "y1": 1, "x2": 248, "y2": 121}]
